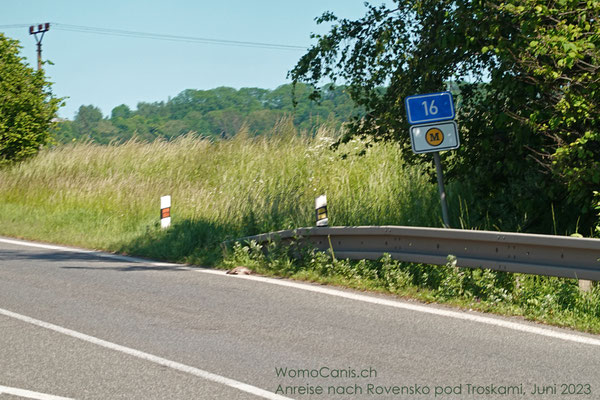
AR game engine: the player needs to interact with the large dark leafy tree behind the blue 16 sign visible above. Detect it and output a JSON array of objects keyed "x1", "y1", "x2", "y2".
[{"x1": 290, "y1": 0, "x2": 600, "y2": 231}]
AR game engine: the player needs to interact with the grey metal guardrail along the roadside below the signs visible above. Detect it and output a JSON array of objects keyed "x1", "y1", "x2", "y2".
[{"x1": 241, "y1": 226, "x2": 600, "y2": 281}]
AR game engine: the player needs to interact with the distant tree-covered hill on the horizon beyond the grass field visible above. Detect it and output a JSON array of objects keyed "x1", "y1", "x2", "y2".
[{"x1": 55, "y1": 84, "x2": 361, "y2": 144}]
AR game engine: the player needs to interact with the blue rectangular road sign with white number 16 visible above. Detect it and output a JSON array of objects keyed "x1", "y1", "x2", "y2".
[{"x1": 404, "y1": 92, "x2": 455, "y2": 125}]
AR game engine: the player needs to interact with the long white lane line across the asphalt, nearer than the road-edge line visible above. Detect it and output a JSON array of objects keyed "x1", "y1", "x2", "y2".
[{"x1": 0, "y1": 308, "x2": 292, "y2": 400}]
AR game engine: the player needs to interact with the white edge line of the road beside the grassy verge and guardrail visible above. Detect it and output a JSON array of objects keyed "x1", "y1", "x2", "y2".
[{"x1": 0, "y1": 238, "x2": 600, "y2": 346}]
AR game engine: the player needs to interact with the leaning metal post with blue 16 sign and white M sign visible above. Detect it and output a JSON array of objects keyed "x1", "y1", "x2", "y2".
[{"x1": 404, "y1": 92, "x2": 460, "y2": 228}]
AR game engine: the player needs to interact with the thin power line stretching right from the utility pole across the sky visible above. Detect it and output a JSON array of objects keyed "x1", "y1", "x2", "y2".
[{"x1": 44, "y1": 22, "x2": 306, "y2": 51}]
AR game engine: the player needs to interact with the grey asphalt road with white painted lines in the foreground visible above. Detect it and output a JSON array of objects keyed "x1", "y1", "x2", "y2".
[{"x1": 0, "y1": 238, "x2": 600, "y2": 400}]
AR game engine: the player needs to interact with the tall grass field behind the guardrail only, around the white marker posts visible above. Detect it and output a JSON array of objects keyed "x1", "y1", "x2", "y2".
[{"x1": 0, "y1": 121, "x2": 439, "y2": 265}]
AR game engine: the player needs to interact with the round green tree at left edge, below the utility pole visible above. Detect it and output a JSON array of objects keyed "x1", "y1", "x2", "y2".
[{"x1": 0, "y1": 33, "x2": 61, "y2": 164}]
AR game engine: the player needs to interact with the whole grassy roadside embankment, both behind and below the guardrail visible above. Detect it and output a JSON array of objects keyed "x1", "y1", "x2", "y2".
[{"x1": 0, "y1": 124, "x2": 600, "y2": 332}]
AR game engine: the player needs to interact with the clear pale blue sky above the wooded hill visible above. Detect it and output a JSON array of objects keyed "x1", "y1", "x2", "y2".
[{"x1": 0, "y1": 0, "x2": 382, "y2": 119}]
